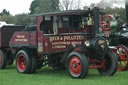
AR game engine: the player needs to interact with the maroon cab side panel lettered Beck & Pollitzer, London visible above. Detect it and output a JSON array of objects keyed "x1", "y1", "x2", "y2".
[{"x1": 43, "y1": 34, "x2": 92, "y2": 53}]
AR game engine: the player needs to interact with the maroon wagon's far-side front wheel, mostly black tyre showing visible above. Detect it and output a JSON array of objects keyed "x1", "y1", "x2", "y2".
[{"x1": 98, "y1": 49, "x2": 118, "y2": 76}]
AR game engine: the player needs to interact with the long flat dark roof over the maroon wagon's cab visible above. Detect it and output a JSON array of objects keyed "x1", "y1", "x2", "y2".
[{"x1": 32, "y1": 10, "x2": 89, "y2": 16}]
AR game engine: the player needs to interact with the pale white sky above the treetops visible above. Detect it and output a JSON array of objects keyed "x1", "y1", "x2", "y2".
[{"x1": 0, "y1": 0, "x2": 125, "y2": 15}]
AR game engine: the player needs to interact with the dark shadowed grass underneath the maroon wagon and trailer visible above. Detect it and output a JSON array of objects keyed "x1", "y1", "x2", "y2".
[{"x1": 3, "y1": 65, "x2": 114, "y2": 80}]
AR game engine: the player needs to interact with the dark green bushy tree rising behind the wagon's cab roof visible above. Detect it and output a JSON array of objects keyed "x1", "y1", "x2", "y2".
[{"x1": 30, "y1": 0, "x2": 59, "y2": 14}]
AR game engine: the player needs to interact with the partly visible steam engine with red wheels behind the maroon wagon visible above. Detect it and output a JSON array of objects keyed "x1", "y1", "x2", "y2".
[{"x1": 100, "y1": 0, "x2": 128, "y2": 71}]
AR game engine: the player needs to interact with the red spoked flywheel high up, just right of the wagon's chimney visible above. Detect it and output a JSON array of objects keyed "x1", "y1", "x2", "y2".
[{"x1": 100, "y1": 15, "x2": 115, "y2": 31}]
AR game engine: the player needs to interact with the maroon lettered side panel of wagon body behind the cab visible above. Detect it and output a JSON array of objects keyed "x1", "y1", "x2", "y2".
[{"x1": 9, "y1": 32, "x2": 36, "y2": 47}]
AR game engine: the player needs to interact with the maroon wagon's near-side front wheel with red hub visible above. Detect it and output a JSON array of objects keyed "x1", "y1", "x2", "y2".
[{"x1": 66, "y1": 52, "x2": 88, "y2": 78}]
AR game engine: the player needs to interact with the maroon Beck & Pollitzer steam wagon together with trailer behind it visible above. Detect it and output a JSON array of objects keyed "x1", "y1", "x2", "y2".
[{"x1": 0, "y1": 8, "x2": 118, "y2": 78}]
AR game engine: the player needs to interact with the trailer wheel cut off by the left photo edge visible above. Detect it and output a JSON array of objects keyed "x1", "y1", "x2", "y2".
[{"x1": 0, "y1": 50, "x2": 7, "y2": 69}]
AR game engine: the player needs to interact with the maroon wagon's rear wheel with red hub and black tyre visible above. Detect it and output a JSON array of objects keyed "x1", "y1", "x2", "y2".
[{"x1": 16, "y1": 50, "x2": 32, "y2": 73}]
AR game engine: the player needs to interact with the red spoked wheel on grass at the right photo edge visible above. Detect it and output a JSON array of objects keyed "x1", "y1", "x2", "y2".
[{"x1": 117, "y1": 45, "x2": 128, "y2": 71}]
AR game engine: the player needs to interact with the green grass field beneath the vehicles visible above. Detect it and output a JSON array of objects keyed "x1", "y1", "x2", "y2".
[{"x1": 0, "y1": 65, "x2": 128, "y2": 85}]
